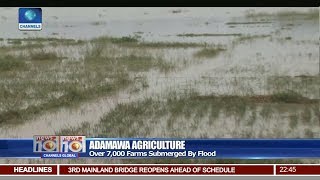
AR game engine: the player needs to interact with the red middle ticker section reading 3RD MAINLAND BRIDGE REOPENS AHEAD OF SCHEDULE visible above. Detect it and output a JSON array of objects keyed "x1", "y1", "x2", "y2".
[{"x1": 60, "y1": 165, "x2": 274, "y2": 175}]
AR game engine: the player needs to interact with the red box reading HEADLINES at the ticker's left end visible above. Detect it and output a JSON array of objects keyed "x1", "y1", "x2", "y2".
[{"x1": 0, "y1": 165, "x2": 57, "y2": 175}]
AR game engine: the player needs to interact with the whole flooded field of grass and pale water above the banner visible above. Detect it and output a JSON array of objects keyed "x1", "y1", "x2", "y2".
[{"x1": 0, "y1": 8, "x2": 320, "y2": 163}]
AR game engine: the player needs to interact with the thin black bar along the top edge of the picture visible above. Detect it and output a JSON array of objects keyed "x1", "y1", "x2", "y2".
[{"x1": 0, "y1": 0, "x2": 320, "y2": 7}]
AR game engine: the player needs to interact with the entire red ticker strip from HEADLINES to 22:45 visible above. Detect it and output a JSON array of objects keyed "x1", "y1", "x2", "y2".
[{"x1": 0, "y1": 164, "x2": 320, "y2": 176}]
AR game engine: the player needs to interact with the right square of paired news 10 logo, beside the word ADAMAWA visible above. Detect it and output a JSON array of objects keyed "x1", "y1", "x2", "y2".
[{"x1": 60, "y1": 136, "x2": 86, "y2": 153}]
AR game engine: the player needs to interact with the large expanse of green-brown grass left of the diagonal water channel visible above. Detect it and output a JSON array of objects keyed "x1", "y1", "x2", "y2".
[{"x1": 0, "y1": 34, "x2": 188, "y2": 124}]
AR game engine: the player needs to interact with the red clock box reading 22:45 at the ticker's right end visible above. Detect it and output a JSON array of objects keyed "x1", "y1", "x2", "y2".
[{"x1": 276, "y1": 165, "x2": 320, "y2": 175}]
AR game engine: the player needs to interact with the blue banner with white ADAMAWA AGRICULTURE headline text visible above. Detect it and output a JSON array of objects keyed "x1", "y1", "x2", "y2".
[{"x1": 0, "y1": 135, "x2": 320, "y2": 159}]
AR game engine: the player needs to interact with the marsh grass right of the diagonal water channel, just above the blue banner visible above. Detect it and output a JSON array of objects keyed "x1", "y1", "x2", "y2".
[{"x1": 57, "y1": 91, "x2": 317, "y2": 138}]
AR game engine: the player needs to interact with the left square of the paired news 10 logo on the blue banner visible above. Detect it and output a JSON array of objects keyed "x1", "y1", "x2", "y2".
[{"x1": 33, "y1": 136, "x2": 60, "y2": 152}]
